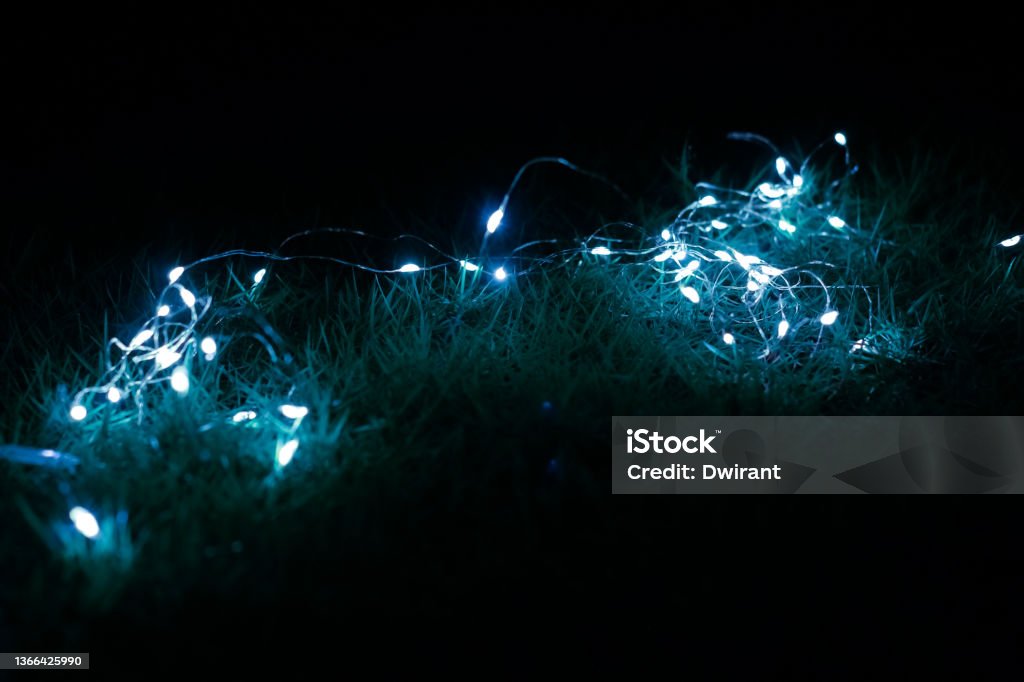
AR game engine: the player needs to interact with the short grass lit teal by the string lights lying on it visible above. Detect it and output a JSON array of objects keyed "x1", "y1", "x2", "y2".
[{"x1": 0, "y1": 142, "x2": 1024, "y2": 650}]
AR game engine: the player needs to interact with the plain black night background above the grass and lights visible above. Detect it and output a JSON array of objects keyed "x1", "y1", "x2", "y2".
[{"x1": 0, "y1": 3, "x2": 1021, "y2": 264}]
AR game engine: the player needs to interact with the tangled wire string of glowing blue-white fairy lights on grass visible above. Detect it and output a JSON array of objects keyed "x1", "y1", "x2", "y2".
[{"x1": 58, "y1": 132, "x2": 1024, "y2": 539}]
